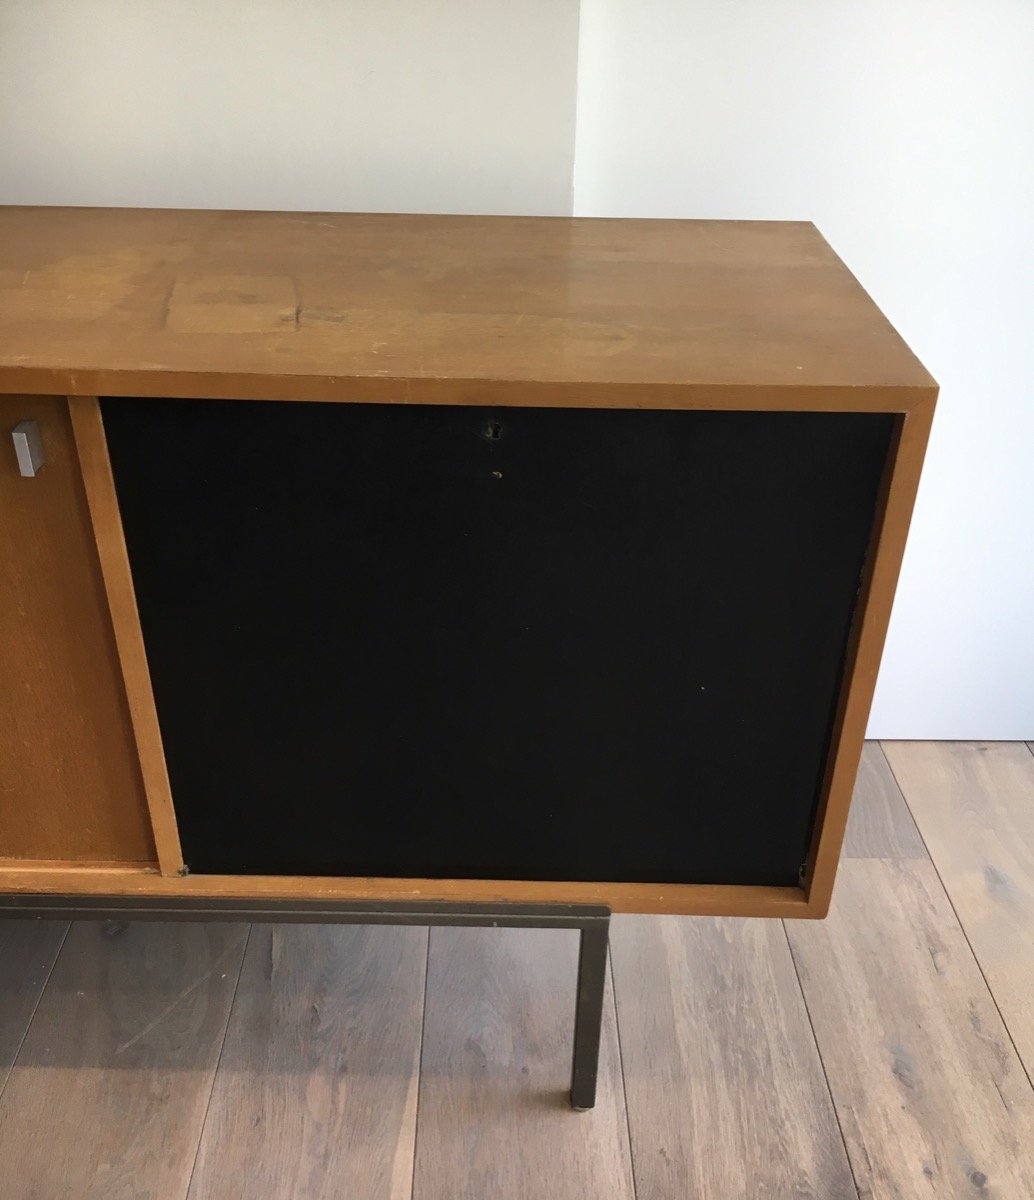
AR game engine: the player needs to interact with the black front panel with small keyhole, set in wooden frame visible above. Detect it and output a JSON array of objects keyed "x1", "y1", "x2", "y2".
[{"x1": 103, "y1": 398, "x2": 894, "y2": 884}]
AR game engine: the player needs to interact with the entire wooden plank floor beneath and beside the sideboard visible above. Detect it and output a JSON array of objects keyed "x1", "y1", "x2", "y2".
[{"x1": 0, "y1": 743, "x2": 1034, "y2": 1200}]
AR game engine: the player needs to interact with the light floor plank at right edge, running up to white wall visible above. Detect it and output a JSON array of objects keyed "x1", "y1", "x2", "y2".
[{"x1": 885, "y1": 742, "x2": 1034, "y2": 1076}]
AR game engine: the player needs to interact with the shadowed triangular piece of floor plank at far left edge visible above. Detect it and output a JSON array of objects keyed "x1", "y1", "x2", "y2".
[{"x1": 0, "y1": 920, "x2": 68, "y2": 1094}]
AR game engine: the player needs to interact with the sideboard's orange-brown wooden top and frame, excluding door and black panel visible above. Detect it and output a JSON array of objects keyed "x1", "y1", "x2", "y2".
[{"x1": 0, "y1": 216, "x2": 937, "y2": 916}]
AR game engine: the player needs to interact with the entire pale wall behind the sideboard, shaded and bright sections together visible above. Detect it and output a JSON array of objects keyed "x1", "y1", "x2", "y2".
[{"x1": 0, "y1": 0, "x2": 1034, "y2": 738}]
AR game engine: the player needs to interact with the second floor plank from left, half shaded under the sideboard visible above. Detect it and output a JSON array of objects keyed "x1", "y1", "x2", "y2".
[{"x1": 0, "y1": 922, "x2": 247, "y2": 1200}]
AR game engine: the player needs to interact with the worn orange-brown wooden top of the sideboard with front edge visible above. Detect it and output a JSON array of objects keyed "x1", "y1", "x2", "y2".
[{"x1": 0, "y1": 206, "x2": 936, "y2": 410}]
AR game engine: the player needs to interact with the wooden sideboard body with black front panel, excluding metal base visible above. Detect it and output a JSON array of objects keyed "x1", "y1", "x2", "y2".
[{"x1": 0, "y1": 208, "x2": 937, "y2": 917}]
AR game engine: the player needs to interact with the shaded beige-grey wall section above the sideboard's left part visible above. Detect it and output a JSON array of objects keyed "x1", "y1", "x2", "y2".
[{"x1": 0, "y1": 0, "x2": 578, "y2": 214}]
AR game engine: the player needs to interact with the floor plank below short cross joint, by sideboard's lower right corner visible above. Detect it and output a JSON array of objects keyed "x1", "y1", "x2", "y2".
[{"x1": 787, "y1": 859, "x2": 1034, "y2": 1200}]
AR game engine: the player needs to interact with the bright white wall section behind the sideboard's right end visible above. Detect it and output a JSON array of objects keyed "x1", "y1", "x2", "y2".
[{"x1": 575, "y1": 0, "x2": 1034, "y2": 738}]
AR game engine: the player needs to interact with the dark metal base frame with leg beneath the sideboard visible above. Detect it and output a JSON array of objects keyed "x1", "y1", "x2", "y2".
[{"x1": 0, "y1": 894, "x2": 611, "y2": 1112}]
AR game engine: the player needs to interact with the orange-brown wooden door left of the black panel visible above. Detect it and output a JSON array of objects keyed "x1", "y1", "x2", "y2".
[{"x1": 0, "y1": 396, "x2": 155, "y2": 862}]
